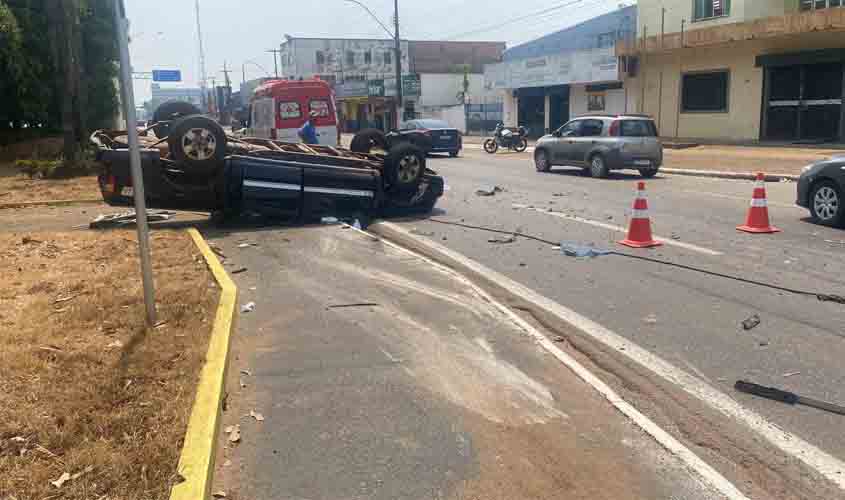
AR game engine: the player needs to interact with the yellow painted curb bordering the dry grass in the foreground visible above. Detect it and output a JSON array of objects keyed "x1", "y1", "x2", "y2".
[{"x1": 170, "y1": 228, "x2": 238, "y2": 500}]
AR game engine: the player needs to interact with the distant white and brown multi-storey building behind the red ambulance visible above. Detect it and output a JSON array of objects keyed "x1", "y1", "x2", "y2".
[{"x1": 280, "y1": 37, "x2": 505, "y2": 132}]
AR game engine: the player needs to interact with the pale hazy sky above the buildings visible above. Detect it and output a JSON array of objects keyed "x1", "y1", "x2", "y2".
[{"x1": 126, "y1": 0, "x2": 632, "y2": 104}]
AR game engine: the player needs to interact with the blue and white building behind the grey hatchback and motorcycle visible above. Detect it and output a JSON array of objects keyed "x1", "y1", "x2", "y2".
[{"x1": 484, "y1": 7, "x2": 637, "y2": 136}]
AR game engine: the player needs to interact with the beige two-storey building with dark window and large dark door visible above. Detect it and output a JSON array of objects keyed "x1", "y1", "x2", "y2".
[{"x1": 617, "y1": 0, "x2": 845, "y2": 142}]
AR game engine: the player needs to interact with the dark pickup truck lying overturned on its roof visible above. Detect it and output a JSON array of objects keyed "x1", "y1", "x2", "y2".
[{"x1": 91, "y1": 109, "x2": 444, "y2": 222}]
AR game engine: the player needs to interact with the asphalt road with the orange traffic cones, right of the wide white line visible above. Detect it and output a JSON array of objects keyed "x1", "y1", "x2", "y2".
[{"x1": 400, "y1": 150, "x2": 845, "y2": 459}]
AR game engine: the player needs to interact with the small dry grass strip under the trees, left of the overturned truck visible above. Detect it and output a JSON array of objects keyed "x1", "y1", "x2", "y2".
[{"x1": 0, "y1": 164, "x2": 100, "y2": 204}]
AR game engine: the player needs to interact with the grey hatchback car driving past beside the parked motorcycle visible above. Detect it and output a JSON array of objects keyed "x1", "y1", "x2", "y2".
[{"x1": 534, "y1": 115, "x2": 663, "y2": 178}]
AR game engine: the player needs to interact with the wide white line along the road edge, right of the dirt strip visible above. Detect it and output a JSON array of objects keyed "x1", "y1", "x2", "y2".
[{"x1": 370, "y1": 222, "x2": 845, "y2": 491}]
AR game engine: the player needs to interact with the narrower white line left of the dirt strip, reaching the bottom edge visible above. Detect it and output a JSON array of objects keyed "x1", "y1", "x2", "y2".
[{"x1": 360, "y1": 222, "x2": 749, "y2": 500}]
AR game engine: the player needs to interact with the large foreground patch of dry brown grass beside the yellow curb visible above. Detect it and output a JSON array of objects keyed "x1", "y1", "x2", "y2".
[{"x1": 0, "y1": 231, "x2": 218, "y2": 500}]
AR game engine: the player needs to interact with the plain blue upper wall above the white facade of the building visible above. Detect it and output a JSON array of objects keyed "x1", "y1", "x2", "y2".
[{"x1": 503, "y1": 5, "x2": 637, "y2": 61}]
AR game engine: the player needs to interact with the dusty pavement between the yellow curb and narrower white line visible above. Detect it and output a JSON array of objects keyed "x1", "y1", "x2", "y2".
[{"x1": 207, "y1": 226, "x2": 721, "y2": 500}]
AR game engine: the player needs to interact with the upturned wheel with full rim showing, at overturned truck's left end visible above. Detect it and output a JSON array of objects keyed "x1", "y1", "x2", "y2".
[{"x1": 167, "y1": 116, "x2": 226, "y2": 176}]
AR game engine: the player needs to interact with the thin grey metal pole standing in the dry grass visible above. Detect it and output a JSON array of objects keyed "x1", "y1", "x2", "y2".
[{"x1": 114, "y1": 0, "x2": 156, "y2": 327}]
